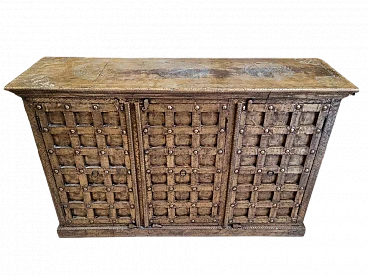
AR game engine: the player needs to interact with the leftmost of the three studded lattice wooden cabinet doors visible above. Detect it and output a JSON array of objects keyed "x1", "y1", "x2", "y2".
[{"x1": 29, "y1": 100, "x2": 140, "y2": 226}]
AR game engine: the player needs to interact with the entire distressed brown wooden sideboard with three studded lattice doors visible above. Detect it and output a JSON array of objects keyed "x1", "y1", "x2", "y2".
[{"x1": 5, "y1": 57, "x2": 359, "y2": 239}]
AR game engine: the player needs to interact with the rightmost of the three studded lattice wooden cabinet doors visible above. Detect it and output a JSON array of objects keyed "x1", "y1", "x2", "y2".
[{"x1": 225, "y1": 100, "x2": 330, "y2": 227}]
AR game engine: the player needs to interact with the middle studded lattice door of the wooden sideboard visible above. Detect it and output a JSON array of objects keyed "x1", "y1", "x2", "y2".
[{"x1": 136, "y1": 100, "x2": 230, "y2": 226}]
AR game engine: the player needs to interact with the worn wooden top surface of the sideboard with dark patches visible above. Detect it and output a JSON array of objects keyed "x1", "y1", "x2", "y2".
[{"x1": 4, "y1": 56, "x2": 359, "y2": 94}]
